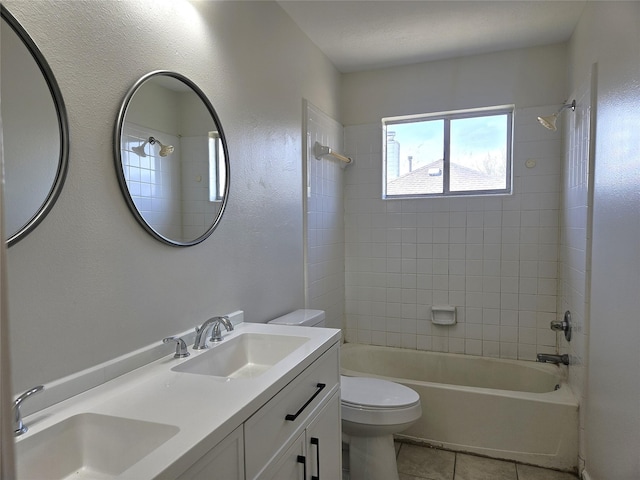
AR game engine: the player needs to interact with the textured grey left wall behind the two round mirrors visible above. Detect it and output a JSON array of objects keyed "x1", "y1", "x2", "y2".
[{"x1": 4, "y1": 0, "x2": 339, "y2": 392}]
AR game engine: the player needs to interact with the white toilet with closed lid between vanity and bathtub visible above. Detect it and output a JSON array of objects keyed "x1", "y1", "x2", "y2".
[{"x1": 269, "y1": 309, "x2": 422, "y2": 480}]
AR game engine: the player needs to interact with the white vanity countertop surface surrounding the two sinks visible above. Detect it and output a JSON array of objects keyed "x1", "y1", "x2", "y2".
[{"x1": 17, "y1": 323, "x2": 340, "y2": 480}]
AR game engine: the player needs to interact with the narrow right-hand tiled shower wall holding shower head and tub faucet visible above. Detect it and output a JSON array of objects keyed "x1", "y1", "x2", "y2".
[{"x1": 558, "y1": 72, "x2": 592, "y2": 472}]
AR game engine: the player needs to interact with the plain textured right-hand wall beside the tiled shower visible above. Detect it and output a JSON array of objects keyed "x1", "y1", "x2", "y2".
[{"x1": 569, "y1": 2, "x2": 640, "y2": 480}]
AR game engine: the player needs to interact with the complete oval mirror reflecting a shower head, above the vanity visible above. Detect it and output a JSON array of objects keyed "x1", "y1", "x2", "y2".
[{"x1": 115, "y1": 71, "x2": 229, "y2": 247}]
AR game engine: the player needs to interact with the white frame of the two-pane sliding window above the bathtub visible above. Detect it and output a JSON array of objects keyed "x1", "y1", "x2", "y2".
[{"x1": 382, "y1": 105, "x2": 515, "y2": 200}]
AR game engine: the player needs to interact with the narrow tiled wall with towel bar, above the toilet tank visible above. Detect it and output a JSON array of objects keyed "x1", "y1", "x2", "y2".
[{"x1": 304, "y1": 103, "x2": 344, "y2": 328}]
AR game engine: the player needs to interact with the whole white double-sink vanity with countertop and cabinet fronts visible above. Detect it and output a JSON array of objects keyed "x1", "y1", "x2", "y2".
[{"x1": 16, "y1": 320, "x2": 341, "y2": 480}]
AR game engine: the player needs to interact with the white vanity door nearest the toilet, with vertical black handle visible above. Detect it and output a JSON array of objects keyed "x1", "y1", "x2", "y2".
[{"x1": 307, "y1": 392, "x2": 342, "y2": 480}]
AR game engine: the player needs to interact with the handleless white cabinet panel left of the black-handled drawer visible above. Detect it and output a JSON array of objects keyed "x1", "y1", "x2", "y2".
[{"x1": 178, "y1": 426, "x2": 244, "y2": 480}]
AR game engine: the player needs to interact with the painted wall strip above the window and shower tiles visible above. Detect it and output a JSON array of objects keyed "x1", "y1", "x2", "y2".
[{"x1": 341, "y1": 45, "x2": 567, "y2": 127}]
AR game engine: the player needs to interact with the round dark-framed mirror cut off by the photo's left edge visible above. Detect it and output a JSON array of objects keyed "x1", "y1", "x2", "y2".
[{"x1": 0, "y1": 6, "x2": 69, "y2": 246}]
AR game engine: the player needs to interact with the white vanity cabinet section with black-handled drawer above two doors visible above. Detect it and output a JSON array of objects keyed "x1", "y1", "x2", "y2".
[{"x1": 244, "y1": 345, "x2": 342, "y2": 480}]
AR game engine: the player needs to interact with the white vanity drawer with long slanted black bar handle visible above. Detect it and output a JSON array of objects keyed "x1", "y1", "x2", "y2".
[{"x1": 244, "y1": 345, "x2": 339, "y2": 479}]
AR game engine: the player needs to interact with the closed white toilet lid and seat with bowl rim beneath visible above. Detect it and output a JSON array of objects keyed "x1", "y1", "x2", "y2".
[{"x1": 340, "y1": 376, "x2": 422, "y2": 425}]
